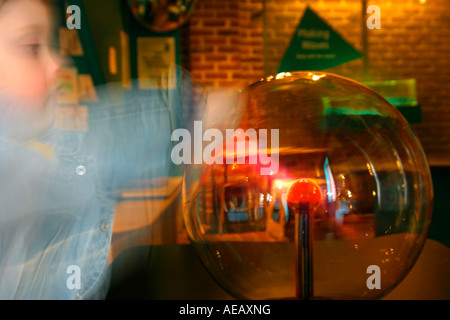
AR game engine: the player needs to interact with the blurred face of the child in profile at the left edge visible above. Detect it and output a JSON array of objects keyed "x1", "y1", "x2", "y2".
[{"x1": 0, "y1": 0, "x2": 59, "y2": 140}]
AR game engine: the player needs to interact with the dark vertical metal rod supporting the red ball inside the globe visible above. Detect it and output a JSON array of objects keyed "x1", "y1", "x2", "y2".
[{"x1": 295, "y1": 202, "x2": 313, "y2": 300}]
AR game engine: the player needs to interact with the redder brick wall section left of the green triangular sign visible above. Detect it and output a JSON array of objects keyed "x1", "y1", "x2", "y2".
[{"x1": 185, "y1": 0, "x2": 264, "y2": 87}]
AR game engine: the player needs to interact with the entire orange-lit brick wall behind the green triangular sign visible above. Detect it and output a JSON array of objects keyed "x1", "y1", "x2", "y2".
[{"x1": 186, "y1": 0, "x2": 450, "y2": 164}]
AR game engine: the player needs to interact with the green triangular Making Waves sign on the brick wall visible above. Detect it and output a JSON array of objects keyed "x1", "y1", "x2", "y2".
[{"x1": 278, "y1": 7, "x2": 362, "y2": 72}]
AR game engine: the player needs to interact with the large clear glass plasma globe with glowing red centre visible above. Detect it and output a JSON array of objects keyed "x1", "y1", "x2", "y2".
[{"x1": 184, "y1": 72, "x2": 433, "y2": 299}]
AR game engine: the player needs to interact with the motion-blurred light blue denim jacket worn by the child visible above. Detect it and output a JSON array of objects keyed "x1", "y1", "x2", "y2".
[{"x1": 0, "y1": 80, "x2": 185, "y2": 299}]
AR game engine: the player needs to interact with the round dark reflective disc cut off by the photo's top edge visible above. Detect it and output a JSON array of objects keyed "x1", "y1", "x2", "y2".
[{"x1": 128, "y1": 0, "x2": 197, "y2": 32}]
